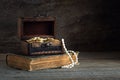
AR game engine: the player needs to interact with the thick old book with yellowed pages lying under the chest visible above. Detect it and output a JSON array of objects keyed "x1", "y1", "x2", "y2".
[{"x1": 6, "y1": 54, "x2": 76, "y2": 71}]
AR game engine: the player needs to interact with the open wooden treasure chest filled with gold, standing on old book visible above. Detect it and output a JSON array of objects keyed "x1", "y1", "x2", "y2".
[{"x1": 18, "y1": 17, "x2": 63, "y2": 55}]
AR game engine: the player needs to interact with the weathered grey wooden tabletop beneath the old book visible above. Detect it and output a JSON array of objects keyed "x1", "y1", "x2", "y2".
[{"x1": 0, "y1": 54, "x2": 120, "y2": 80}]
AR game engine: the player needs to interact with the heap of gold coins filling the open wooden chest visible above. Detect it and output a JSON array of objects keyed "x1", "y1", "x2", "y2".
[{"x1": 26, "y1": 37, "x2": 61, "y2": 47}]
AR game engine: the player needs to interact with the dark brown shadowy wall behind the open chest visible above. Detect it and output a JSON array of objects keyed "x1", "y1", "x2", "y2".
[{"x1": 0, "y1": 0, "x2": 120, "y2": 57}]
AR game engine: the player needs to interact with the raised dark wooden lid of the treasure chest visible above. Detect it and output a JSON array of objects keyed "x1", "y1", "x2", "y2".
[{"x1": 18, "y1": 17, "x2": 55, "y2": 40}]
